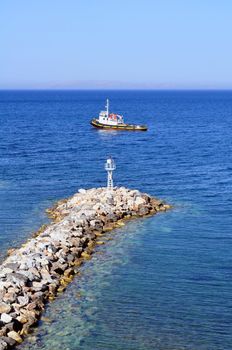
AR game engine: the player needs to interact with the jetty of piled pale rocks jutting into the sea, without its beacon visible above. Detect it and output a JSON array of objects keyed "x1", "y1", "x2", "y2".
[{"x1": 0, "y1": 187, "x2": 170, "y2": 350}]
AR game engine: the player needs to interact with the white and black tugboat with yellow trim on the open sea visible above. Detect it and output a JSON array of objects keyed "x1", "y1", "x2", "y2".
[{"x1": 90, "y1": 99, "x2": 147, "y2": 131}]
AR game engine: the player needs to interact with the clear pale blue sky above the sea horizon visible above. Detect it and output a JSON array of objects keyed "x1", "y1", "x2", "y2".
[{"x1": 0, "y1": 0, "x2": 232, "y2": 89}]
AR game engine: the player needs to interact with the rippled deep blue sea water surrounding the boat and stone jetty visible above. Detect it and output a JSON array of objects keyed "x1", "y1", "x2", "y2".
[{"x1": 0, "y1": 91, "x2": 232, "y2": 350}]
